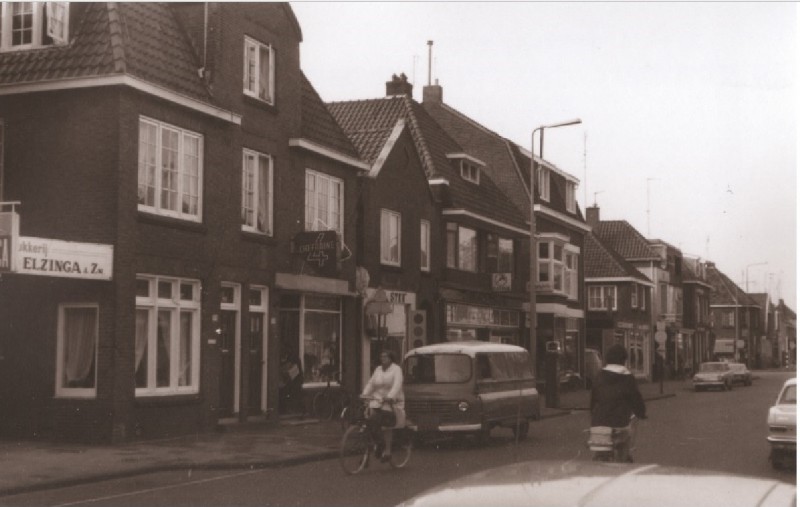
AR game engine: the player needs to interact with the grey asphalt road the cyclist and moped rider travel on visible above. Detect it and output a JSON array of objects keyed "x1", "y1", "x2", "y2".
[{"x1": 0, "y1": 372, "x2": 796, "y2": 506}]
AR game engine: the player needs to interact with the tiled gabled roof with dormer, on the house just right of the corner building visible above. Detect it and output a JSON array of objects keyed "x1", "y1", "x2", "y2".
[{"x1": 328, "y1": 96, "x2": 528, "y2": 230}]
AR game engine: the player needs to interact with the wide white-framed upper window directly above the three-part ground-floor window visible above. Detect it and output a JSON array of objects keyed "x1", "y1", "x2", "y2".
[{"x1": 138, "y1": 118, "x2": 203, "y2": 222}]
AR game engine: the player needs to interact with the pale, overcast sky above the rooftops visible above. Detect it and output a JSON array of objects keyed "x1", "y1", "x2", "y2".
[{"x1": 292, "y1": 2, "x2": 800, "y2": 309}]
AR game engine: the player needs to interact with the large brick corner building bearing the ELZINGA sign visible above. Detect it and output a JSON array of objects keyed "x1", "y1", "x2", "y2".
[{"x1": 0, "y1": 3, "x2": 368, "y2": 441}]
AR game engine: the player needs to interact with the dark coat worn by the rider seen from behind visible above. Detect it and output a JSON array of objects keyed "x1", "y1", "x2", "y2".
[{"x1": 590, "y1": 370, "x2": 646, "y2": 428}]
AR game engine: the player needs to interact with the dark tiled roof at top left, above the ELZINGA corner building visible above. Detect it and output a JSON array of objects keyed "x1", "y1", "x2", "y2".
[{"x1": 0, "y1": 2, "x2": 211, "y2": 102}]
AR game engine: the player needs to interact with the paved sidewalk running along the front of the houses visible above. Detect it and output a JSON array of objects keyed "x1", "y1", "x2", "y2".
[{"x1": 0, "y1": 382, "x2": 685, "y2": 497}]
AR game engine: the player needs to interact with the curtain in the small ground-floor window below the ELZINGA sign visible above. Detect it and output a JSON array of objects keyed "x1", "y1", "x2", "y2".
[{"x1": 64, "y1": 308, "x2": 97, "y2": 387}]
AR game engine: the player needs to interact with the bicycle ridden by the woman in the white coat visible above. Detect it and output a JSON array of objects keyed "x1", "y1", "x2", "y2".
[{"x1": 339, "y1": 399, "x2": 412, "y2": 475}]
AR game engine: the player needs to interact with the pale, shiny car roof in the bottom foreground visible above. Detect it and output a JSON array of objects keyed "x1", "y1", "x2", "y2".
[{"x1": 400, "y1": 461, "x2": 797, "y2": 507}]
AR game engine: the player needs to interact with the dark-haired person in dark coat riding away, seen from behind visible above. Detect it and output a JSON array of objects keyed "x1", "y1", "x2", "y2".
[{"x1": 589, "y1": 344, "x2": 646, "y2": 461}]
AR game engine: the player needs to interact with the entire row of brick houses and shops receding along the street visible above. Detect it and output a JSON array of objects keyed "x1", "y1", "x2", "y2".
[{"x1": 0, "y1": 2, "x2": 794, "y2": 442}]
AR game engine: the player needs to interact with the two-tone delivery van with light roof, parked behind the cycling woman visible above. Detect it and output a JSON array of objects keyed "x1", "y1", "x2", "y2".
[{"x1": 403, "y1": 340, "x2": 540, "y2": 440}]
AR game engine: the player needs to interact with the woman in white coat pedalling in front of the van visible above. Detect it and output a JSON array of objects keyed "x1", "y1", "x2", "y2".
[{"x1": 361, "y1": 350, "x2": 405, "y2": 461}]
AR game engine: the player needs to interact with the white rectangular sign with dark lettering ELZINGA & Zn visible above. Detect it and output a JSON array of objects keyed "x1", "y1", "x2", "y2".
[{"x1": 16, "y1": 236, "x2": 114, "y2": 280}]
